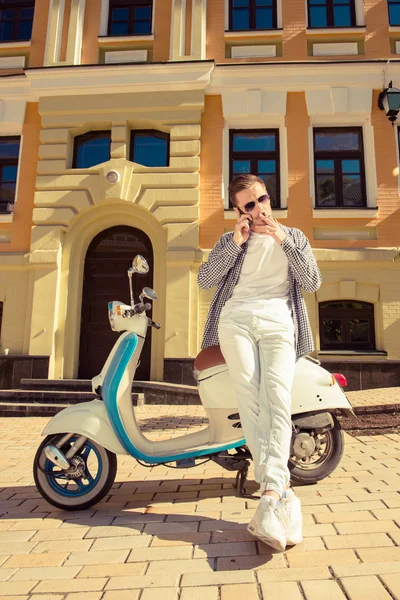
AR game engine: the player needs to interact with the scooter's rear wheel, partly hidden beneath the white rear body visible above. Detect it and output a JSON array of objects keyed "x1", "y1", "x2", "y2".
[{"x1": 288, "y1": 415, "x2": 344, "y2": 485}]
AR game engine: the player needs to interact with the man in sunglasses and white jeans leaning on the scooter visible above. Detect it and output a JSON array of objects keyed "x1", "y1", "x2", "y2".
[{"x1": 198, "y1": 174, "x2": 321, "y2": 550}]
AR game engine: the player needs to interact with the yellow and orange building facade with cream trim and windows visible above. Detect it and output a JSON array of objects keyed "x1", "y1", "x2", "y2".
[{"x1": 0, "y1": 0, "x2": 400, "y2": 388}]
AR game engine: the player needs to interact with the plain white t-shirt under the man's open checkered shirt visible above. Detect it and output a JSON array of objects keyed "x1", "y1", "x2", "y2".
[{"x1": 221, "y1": 231, "x2": 290, "y2": 317}]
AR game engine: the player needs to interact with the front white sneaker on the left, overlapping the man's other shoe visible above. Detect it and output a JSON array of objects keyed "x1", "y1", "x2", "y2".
[{"x1": 247, "y1": 496, "x2": 286, "y2": 552}]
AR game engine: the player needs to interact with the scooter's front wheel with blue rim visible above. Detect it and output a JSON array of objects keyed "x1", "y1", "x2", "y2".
[{"x1": 33, "y1": 434, "x2": 117, "y2": 510}]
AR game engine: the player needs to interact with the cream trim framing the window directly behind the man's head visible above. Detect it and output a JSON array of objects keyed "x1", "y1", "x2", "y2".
[{"x1": 222, "y1": 114, "x2": 289, "y2": 211}]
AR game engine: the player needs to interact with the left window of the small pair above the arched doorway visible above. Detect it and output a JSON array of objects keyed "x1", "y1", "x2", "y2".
[{"x1": 72, "y1": 131, "x2": 111, "y2": 169}]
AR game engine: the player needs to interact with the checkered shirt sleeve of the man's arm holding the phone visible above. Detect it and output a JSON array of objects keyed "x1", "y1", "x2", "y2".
[{"x1": 197, "y1": 237, "x2": 242, "y2": 290}]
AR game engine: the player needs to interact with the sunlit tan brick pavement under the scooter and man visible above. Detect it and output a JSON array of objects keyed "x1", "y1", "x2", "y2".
[{"x1": 0, "y1": 406, "x2": 400, "y2": 600}]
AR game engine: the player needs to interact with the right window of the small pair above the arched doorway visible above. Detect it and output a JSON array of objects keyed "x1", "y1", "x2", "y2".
[{"x1": 129, "y1": 129, "x2": 169, "y2": 167}]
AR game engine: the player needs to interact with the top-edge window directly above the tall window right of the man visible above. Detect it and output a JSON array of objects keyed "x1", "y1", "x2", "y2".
[{"x1": 308, "y1": 0, "x2": 356, "y2": 27}]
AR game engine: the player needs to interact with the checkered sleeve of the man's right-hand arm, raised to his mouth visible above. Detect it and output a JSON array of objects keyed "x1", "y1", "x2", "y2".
[{"x1": 281, "y1": 229, "x2": 322, "y2": 292}]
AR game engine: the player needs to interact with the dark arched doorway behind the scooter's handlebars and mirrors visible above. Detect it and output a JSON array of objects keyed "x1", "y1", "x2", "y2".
[{"x1": 78, "y1": 226, "x2": 154, "y2": 380}]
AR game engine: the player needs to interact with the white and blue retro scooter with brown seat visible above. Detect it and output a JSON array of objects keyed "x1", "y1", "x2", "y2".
[{"x1": 33, "y1": 255, "x2": 352, "y2": 510}]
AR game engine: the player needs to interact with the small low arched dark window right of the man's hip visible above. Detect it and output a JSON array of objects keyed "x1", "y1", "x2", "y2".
[{"x1": 319, "y1": 300, "x2": 375, "y2": 350}]
